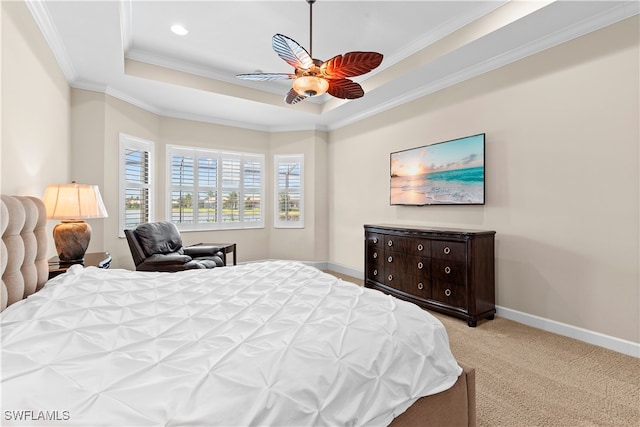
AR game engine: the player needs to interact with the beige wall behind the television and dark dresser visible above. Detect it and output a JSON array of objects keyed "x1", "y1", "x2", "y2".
[{"x1": 329, "y1": 19, "x2": 640, "y2": 342}]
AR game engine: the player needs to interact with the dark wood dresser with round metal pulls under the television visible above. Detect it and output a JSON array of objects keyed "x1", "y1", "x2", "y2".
[{"x1": 364, "y1": 225, "x2": 496, "y2": 327}]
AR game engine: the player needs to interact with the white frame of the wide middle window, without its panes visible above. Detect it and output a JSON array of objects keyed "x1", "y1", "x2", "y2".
[{"x1": 165, "y1": 145, "x2": 266, "y2": 231}]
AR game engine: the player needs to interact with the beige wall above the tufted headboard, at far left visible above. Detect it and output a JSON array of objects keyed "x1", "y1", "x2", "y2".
[{"x1": 0, "y1": 1, "x2": 70, "y2": 255}]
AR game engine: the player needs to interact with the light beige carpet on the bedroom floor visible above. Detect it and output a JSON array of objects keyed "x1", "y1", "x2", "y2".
[{"x1": 331, "y1": 272, "x2": 640, "y2": 427}]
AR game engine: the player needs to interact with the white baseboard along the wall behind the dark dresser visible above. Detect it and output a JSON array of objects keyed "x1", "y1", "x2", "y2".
[{"x1": 324, "y1": 262, "x2": 640, "y2": 358}]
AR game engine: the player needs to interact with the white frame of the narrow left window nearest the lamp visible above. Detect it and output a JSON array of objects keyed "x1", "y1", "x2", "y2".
[{"x1": 118, "y1": 132, "x2": 155, "y2": 237}]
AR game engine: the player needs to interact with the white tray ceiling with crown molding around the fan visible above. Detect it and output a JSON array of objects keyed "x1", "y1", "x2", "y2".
[{"x1": 27, "y1": 0, "x2": 640, "y2": 131}]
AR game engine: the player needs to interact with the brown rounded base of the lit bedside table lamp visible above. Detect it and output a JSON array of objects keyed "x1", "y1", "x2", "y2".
[{"x1": 53, "y1": 220, "x2": 91, "y2": 264}]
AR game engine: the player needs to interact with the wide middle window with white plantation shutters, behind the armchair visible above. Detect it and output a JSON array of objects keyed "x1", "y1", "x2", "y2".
[{"x1": 167, "y1": 145, "x2": 264, "y2": 230}]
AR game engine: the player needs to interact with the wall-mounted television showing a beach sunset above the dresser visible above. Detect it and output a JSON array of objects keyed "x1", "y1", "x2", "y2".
[{"x1": 390, "y1": 133, "x2": 485, "y2": 206}]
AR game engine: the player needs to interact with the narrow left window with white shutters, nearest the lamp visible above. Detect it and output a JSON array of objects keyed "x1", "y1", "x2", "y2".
[{"x1": 119, "y1": 133, "x2": 153, "y2": 237}]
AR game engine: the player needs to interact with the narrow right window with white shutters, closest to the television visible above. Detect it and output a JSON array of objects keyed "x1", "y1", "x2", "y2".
[{"x1": 274, "y1": 154, "x2": 304, "y2": 228}]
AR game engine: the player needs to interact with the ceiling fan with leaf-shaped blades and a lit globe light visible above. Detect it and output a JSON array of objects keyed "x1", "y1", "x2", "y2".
[{"x1": 236, "y1": 0, "x2": 382, "y2": 104}]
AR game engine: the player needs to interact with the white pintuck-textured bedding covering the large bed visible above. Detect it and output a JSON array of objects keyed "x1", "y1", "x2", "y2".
[{"x1": 1, "y1": 261, "x2": 461, "y2": 426}]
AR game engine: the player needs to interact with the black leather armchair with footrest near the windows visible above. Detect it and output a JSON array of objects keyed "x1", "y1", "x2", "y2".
[{"x1": 124, "y1": 221, "x2": 223, "y2": 271}]
